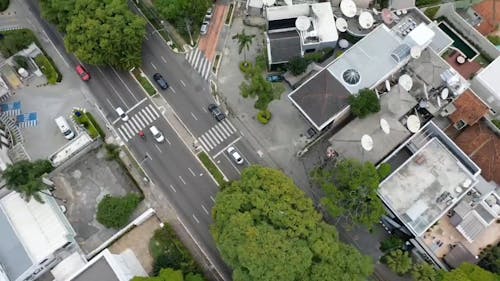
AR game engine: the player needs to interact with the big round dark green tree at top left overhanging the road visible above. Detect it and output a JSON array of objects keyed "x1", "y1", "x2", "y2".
[{"x1": 64, "y1": 0, "x2": 146, "y2": 70}]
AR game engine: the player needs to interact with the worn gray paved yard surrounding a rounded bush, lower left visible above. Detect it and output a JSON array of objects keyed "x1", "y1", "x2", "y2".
[{"x1": 52, "y1": 147, "x2": 146, "y2": 253}]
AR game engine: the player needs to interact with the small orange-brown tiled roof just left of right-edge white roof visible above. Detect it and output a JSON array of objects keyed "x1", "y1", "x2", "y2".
[{"x1": 449, "y1": 90, "x2": 489, "y2": 125}]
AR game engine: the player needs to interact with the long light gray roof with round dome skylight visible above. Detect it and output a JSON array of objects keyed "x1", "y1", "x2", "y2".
[{"x1": 328, "y1": 24, "x2": 409, "y2": 93}]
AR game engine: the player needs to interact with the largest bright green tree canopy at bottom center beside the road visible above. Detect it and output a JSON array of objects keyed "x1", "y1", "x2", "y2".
[{"x1": 212, "y1": 166, "x2": 373, "y2": 281}]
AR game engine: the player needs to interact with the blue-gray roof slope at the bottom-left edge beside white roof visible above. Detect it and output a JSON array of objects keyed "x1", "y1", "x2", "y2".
[{"x1": 0, "y1": 208, "x2": 33, "y2": 280}]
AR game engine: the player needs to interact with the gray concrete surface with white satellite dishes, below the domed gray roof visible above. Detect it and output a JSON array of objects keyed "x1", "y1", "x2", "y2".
[{"x1": 329, "y1": 87, "x2": 417, "y2": 163}]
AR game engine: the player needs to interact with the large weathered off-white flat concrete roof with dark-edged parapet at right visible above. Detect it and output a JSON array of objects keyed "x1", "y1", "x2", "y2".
[{"x1": 378, "y1": 122, "x2": 480, "y2": 236}]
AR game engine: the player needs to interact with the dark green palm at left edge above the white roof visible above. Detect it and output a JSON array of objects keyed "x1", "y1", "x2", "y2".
[{"x1": 2, "y1": 160, "x2": 54, "y2": 203}]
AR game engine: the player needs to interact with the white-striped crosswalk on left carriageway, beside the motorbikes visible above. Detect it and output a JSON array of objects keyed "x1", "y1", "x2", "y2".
[{"x1": 118, "y1": 104, "x2": 160, "y2": 141}]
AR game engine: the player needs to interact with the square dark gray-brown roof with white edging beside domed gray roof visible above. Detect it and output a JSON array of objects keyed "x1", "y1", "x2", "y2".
[{"x1": 288, "y1": 69, "x2": 351, "y2": 130}]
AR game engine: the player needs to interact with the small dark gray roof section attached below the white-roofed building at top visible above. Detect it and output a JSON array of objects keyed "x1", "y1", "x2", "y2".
[{"x1": 268, "y1": 30, "x2": 301, "y2": 63}]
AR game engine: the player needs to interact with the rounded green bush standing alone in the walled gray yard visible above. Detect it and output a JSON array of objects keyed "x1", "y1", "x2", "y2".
[{"x1": 97, "y1": 193, "x2": 142, "y2": 228}]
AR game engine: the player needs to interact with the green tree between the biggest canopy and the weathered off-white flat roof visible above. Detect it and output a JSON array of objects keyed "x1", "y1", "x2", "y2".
[{"x1": 312, "y1": 159, "x2": 385, "y2": 228}]
